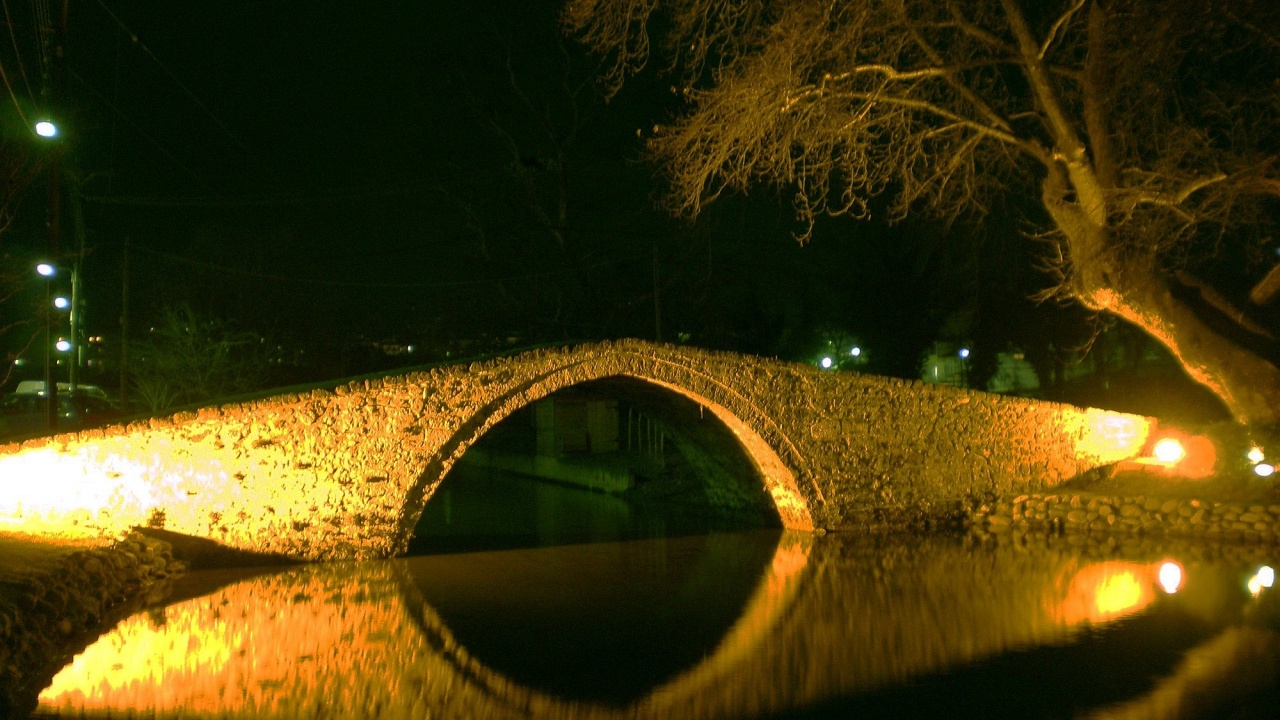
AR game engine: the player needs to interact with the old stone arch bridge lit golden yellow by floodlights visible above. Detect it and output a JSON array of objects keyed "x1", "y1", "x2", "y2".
[{"x1": 0, "y1": 341, "x2": 1149, "y2": 560}]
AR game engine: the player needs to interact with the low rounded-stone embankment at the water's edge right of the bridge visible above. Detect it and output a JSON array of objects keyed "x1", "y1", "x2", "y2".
[{"x1": 969, "y1": 493, "x2": 1280, "y2": 544}]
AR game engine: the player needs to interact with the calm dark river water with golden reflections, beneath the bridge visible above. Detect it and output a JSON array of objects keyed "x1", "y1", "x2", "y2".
[{"x1": 30, "y1": 461, "x2": 1280, "y2": 719}]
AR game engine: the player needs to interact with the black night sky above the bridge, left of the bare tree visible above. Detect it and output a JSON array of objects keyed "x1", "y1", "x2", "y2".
[{"x1": 0, "y1": 0, "x2": 1100, "y2": 392}]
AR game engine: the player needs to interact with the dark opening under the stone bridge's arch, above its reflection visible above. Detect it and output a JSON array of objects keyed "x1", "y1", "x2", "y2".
[{"x1": 408, "y1": 375, "x2": 783, "y2": 555}]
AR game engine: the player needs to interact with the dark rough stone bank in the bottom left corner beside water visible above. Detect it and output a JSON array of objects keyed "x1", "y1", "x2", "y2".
[{"x1": 0, "y1": 533, "x2": 187, "y2": 717}]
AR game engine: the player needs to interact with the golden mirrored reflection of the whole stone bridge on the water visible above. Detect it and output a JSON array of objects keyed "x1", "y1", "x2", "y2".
[{"x1": 41, "y1": 533, "x2": 1254, "y2": 719}]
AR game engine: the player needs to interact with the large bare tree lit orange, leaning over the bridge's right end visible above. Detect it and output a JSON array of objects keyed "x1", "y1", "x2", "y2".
[{"x1": 564, "y1": 0, "x2": 1280, "y2": 427}]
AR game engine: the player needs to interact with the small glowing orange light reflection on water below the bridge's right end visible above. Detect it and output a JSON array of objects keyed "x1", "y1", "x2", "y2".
[{"x1": 1057, "y1": 561, "x2": 1156, "y2": 624}]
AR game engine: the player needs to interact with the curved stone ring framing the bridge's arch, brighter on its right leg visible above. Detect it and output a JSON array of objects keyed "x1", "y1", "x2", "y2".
[{"x1": 397, "y1": 352, "x2": 822, "y2": 548}]
